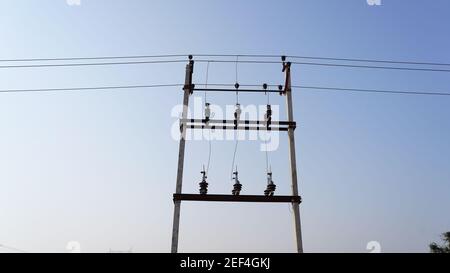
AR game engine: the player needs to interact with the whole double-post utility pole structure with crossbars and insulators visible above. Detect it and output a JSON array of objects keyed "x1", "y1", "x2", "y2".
[{"x1": 171, "y1": 55, "x2": 303, "y2": 253}]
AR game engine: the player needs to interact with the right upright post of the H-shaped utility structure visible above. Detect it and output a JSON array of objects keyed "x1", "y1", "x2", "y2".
[{"x1": 283, "y1": 60, "x2": 303, "y2": 253}]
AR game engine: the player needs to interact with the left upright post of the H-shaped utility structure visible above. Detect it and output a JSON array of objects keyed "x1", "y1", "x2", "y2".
[{"x1": 171, "y1": 56, "x2": 194, "y2": 253}]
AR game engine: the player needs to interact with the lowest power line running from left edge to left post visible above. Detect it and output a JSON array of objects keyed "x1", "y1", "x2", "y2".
[{"x1": 0, "y1": 84, "x2": 184, "y2": 93}]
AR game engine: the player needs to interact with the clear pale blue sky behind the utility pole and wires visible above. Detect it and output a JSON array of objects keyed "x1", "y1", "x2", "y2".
[{"x1": 0, "y1": 0, "x2": 450, "y2": 252}]
